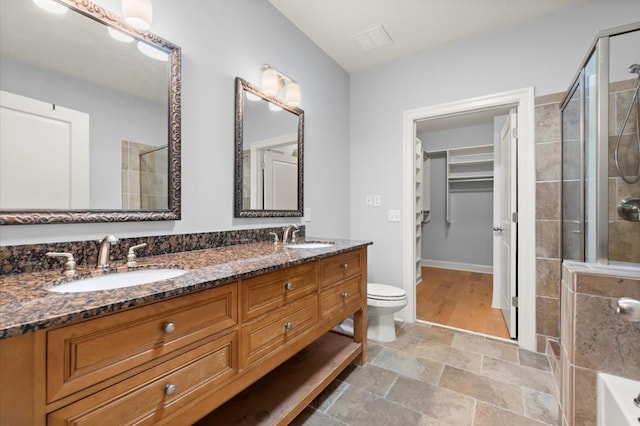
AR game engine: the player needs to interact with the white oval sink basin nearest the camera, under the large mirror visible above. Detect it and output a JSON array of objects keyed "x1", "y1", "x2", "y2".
[{"x1": 47, "y1": 269, "x2": 187, "y2": 293}]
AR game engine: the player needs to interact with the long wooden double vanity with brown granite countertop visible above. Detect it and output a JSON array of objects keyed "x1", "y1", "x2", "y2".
[{"x1": 0, "y1": 240, "x2": 369, "y2": 425}]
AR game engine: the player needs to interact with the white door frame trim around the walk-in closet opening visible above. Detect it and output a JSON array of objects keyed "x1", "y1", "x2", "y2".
[{"x1": 399, "y1": 87, "x2": 537, "y2": 351}]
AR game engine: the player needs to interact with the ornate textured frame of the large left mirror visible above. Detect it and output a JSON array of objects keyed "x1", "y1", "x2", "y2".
[{"x1": 0, "y1": 0, "x2": 181, "y2": 225}]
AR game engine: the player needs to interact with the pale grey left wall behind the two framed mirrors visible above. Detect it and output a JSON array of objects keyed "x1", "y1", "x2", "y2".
[{"x1": 0, "y1": 0, "x2": 349, "y2": 245}]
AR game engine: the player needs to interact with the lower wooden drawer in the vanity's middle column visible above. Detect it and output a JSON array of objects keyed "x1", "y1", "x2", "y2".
[{"x1": 240, "y1": 294, "x2": 318, "y2": 368}]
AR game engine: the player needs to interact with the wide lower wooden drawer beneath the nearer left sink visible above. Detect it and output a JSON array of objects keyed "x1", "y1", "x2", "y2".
[{"x1": 47, "y1": 331, "x2": 238, "y2": 426}]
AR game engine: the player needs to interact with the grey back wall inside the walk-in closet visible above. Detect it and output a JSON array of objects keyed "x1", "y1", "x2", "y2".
[{"x1": 418, "y1": 123, "x2": 494, "y2": 267}]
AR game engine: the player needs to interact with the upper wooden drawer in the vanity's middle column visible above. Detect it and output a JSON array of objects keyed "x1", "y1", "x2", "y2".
[{"x1": 240, "y1": 262, "x2": 318, "y2": 321}]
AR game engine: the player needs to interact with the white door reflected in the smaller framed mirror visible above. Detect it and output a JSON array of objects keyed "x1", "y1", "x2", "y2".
[{"x1": 264, "y1": 151, "x2": 298, "y2": 210}]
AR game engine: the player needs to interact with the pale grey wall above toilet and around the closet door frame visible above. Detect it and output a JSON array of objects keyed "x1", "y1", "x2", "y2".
[{"x1": 350, "y1": 0, "x2": 640, "y2": 286}]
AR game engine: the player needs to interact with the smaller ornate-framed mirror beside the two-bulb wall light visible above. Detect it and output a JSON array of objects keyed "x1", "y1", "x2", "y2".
[{"x1": 234, "y1": 77, "x2": 304, "y2": 217}]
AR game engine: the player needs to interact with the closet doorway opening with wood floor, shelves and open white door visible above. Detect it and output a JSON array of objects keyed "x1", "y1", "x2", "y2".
[{"x1": 415, "y1": 106, "x2": 517, "y2": 338}]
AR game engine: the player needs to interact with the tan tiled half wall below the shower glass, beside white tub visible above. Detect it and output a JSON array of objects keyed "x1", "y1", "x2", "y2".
[{"x1": 559, "y1": 262, "x2": 640, "y2": 426}]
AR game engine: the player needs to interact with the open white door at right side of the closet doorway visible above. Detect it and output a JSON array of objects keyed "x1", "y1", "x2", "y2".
[{"x1": 493, "y1": 109, "x2": 518, "y2": 338}]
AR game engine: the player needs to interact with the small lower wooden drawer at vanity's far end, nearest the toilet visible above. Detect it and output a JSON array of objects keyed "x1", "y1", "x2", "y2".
[{"x1": 320, "y1": 276, "x2": 363, "y2": 321}]
